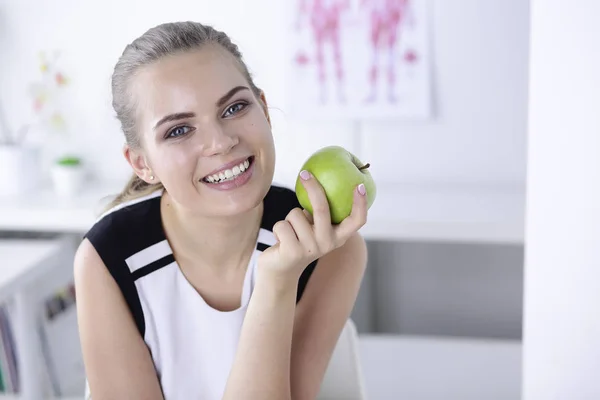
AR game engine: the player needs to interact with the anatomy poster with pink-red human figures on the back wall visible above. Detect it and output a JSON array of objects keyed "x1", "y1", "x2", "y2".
[{"x1": 286, "y1": 0, "x2": 431, "y2": 119}]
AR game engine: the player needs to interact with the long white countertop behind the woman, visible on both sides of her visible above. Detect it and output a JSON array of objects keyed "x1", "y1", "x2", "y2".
[{"x1": 0, "y1": 183, "x2": 525, "y2": 244}]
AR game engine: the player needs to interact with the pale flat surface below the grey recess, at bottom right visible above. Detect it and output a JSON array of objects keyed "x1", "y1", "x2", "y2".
[{"x1": 359, "y1": 335, "x2": 522, "y2": 400}]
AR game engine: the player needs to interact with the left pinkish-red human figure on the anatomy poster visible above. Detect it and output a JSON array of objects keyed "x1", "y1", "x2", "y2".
[{"x1": 297, "y1": 0, "x2": 350, "y2": 103}]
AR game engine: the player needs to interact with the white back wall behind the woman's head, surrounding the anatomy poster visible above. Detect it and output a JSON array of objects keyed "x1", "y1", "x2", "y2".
[{"x1": 0, "y1": 0, "x2": 528, "y2": 188}]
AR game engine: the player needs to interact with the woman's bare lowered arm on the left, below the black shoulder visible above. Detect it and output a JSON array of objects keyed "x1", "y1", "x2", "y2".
[{"x1": 74, "y1": 239, "x2": 163, "y2": 400}]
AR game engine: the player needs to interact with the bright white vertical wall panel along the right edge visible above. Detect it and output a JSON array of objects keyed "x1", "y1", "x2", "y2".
[{"x1": 523, "y1": 0, "x2": 600, "y2": 400}]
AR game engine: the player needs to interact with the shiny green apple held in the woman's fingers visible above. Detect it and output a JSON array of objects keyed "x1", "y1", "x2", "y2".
[{"x1": 296, "y1": 146, "x2": 377, "y2": 224}]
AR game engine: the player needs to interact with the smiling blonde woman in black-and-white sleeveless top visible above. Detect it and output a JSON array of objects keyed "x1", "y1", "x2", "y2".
[{"x1": 75, "y1": 22, "x2": 367, "y2": 400}]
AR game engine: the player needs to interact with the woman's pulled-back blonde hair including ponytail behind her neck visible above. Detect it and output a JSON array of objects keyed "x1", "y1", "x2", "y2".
[{"x1": 107, "y1": 21, "x2": 261, "y2": 209}]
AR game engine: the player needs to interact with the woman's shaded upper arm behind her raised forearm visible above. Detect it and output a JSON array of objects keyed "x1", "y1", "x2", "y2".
[{"x1": 291, "y1": 234, "x2": 367, "y2": 400}]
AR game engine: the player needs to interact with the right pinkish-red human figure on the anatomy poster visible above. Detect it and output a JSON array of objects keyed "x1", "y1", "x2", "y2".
[{"x1": 361, "y1": 0, "x2": 410, "y2": 103}]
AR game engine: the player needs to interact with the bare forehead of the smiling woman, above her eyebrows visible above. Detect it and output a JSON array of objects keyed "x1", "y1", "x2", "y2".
[{"x1": 132, "y1": 45, "x2": 248, "y2": 119}]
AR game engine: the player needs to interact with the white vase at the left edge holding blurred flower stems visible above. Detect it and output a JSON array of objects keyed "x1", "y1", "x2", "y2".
[{"x1": 0, "y1": 144, "x2": 41, "y2": 196}]
